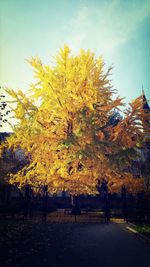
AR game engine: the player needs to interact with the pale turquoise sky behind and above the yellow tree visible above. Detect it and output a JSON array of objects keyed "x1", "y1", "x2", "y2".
[{"x1": 0, "y1": 0, "x2": 150, "y2": 131}]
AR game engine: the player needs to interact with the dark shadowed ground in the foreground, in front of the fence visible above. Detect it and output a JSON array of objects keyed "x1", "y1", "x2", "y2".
[{"x1": 0, "y1": 214, "x2": 150, "y2": 267}]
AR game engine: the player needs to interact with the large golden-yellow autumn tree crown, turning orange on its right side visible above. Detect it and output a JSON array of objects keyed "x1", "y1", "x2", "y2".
[{"x1": 0, "y1": 46, "x2": 149, "y2": 195}]
